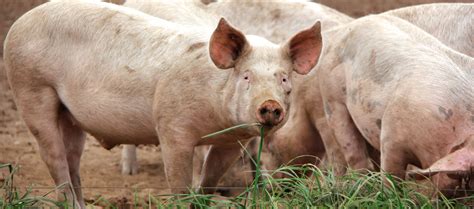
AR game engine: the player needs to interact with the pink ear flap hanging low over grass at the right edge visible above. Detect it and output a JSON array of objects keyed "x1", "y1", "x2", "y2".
[{"x1": 407, "y1": 148, "x2": 474, "y2": 180}]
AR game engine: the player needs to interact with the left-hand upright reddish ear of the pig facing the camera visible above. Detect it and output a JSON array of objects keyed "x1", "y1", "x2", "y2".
[{"x1": 209, "y1": 18, "x2": 247, "y2": 69}]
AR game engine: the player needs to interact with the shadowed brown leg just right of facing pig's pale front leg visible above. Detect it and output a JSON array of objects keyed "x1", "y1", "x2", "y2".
[{"x1": 199, "y1": 143, "x2": 248, "y2": 194}]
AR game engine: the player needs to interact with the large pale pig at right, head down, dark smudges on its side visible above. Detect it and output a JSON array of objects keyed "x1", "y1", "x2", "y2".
[{"x1": 315, "y1": 15, "x2": 474, "y2": 194}]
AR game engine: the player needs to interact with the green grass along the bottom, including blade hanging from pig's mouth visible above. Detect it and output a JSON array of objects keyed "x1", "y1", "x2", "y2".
[{"x1": 0, "y1": 124, "x2": 474, "y2": 209}]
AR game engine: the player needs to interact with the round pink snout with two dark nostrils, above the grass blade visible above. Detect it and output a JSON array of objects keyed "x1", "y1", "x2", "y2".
[{"x1": 256, "y1": 100, "x2": 285, "y2": 126}]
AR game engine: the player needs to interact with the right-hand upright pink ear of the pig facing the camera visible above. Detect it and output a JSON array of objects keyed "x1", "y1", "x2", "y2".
[{"x1": 287, "y1": 21, "x2": 323, "y2": 75}]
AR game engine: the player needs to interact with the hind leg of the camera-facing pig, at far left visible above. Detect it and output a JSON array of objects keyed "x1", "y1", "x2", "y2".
[{"x1": 12, "y1": 85, "x2": 84, "y2": 208}]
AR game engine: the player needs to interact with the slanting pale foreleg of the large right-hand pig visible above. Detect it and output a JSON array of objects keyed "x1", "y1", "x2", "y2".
[{"x1": 324, "y1": 102, "x2": 373, "y2": 170}]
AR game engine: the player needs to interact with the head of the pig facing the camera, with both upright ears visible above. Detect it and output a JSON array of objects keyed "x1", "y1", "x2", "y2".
[{"x1": 209, "y1": 18, "x2": 322, "y2": 134}]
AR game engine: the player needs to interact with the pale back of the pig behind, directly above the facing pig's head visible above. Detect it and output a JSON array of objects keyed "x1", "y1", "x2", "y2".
[{"x1": 207, "y1": 0, "x2": 352, "y2": 43}]
